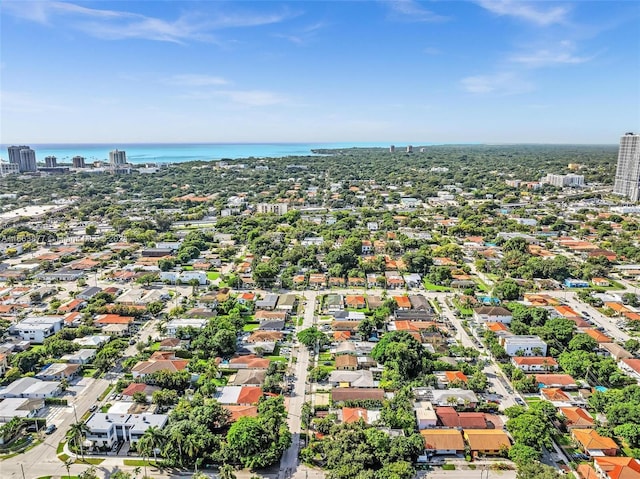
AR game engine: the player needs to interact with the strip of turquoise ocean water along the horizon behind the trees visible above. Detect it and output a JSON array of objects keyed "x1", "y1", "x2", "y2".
[{"x1": 0, "y1": 142, "x2": 432, "y2": 163}]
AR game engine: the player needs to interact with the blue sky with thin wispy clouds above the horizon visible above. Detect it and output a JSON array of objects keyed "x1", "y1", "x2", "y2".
[{"x1": 0, "y1": 0, "x2": 640, "y2": 143}]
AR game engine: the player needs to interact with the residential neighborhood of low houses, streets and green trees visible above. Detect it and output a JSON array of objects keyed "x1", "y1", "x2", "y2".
[{"x1": 0, "y1": 145, "x2": 640, "y2": 479}]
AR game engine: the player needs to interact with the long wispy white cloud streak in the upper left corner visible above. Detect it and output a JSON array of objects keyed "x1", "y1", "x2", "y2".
[{"x1": 2, "y1": 1, "x2": 293, "y2": 43}]
